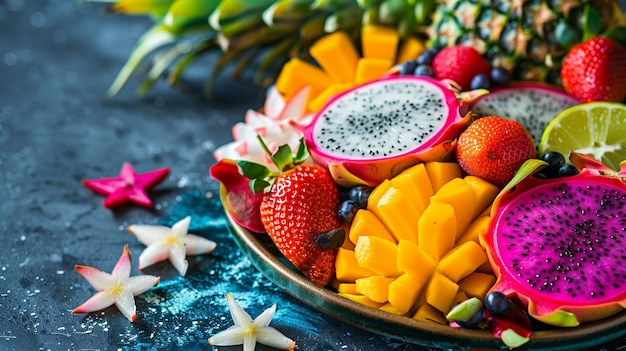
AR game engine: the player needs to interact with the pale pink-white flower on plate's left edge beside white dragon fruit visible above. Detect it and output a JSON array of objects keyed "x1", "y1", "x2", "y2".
[{"x1": 213, "y1": 88, "x2": 309, "y2": 170}]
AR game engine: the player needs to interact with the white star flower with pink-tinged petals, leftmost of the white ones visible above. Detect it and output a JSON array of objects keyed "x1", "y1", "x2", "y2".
[{"x1": 72, "y1": 245, "x2": 160, "y2": 322}]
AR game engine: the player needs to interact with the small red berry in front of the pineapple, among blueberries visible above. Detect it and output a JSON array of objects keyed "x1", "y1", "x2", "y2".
[{"x1": 433, "y1": 45, "x2": 491, "y2": 90}]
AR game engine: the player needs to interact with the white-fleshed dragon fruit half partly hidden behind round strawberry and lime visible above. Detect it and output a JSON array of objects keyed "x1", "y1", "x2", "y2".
[{"x1": 471, "y1": 82, "x2": 580, "y2": 145}]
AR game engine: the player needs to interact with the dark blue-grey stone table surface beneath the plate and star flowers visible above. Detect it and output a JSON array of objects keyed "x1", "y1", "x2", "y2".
[{"x1": 0, "y1": 0, "x2": 626, "y2": 351}]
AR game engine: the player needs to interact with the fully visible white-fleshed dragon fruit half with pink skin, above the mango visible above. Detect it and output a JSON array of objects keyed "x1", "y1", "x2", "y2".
[{"x1": 304, "y1": 76, "x2": 470, "y2": 187}]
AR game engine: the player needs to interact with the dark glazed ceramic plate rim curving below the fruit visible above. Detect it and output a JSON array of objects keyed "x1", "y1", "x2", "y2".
[{"x1": 226, "y1": 209, "x2": 626, "y2": 351}]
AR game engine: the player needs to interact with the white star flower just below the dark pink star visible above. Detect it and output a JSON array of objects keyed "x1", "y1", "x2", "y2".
[{"x1": 127, "y1": 216, "x2": 217, "y2": 276}]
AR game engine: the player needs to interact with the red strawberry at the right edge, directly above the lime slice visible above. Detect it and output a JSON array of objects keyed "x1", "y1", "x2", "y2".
[{"x1": 561, "y1": 37, "x2": 626, "y2": 102}]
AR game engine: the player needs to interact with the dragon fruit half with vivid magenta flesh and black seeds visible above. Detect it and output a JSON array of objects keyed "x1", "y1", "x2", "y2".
[{"x1": 481, "y1": 154, "x2": 626, "y2": 326}]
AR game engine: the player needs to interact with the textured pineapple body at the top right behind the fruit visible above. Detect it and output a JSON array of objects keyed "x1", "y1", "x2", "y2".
[{"x1": 427, "y1": 0, "x2": 626, "y2": 84}]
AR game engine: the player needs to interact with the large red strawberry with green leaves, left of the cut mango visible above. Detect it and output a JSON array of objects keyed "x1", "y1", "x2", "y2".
[{"x1": 238, "y1": 138, "x2": 345, "y2": 286}]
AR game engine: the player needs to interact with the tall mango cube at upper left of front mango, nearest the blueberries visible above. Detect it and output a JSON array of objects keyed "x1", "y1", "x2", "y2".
[{"x1": 368, "y1": 186, "x2": 420, "y2": 242}]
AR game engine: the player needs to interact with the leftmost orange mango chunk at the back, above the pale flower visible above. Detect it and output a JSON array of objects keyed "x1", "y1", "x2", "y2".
[{"x1": 276, "y1": 58, "x2": 332, "y2": 99}]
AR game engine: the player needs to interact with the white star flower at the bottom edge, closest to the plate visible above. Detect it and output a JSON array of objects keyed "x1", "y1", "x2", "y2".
[{"x1": 209, "y1": 294, "x2": 296, "y2": 351}]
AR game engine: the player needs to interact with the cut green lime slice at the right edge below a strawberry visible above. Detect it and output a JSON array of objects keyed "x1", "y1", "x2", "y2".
[{"x1": 539, "y1": 102, "x2": 626, "y2": 170}]
